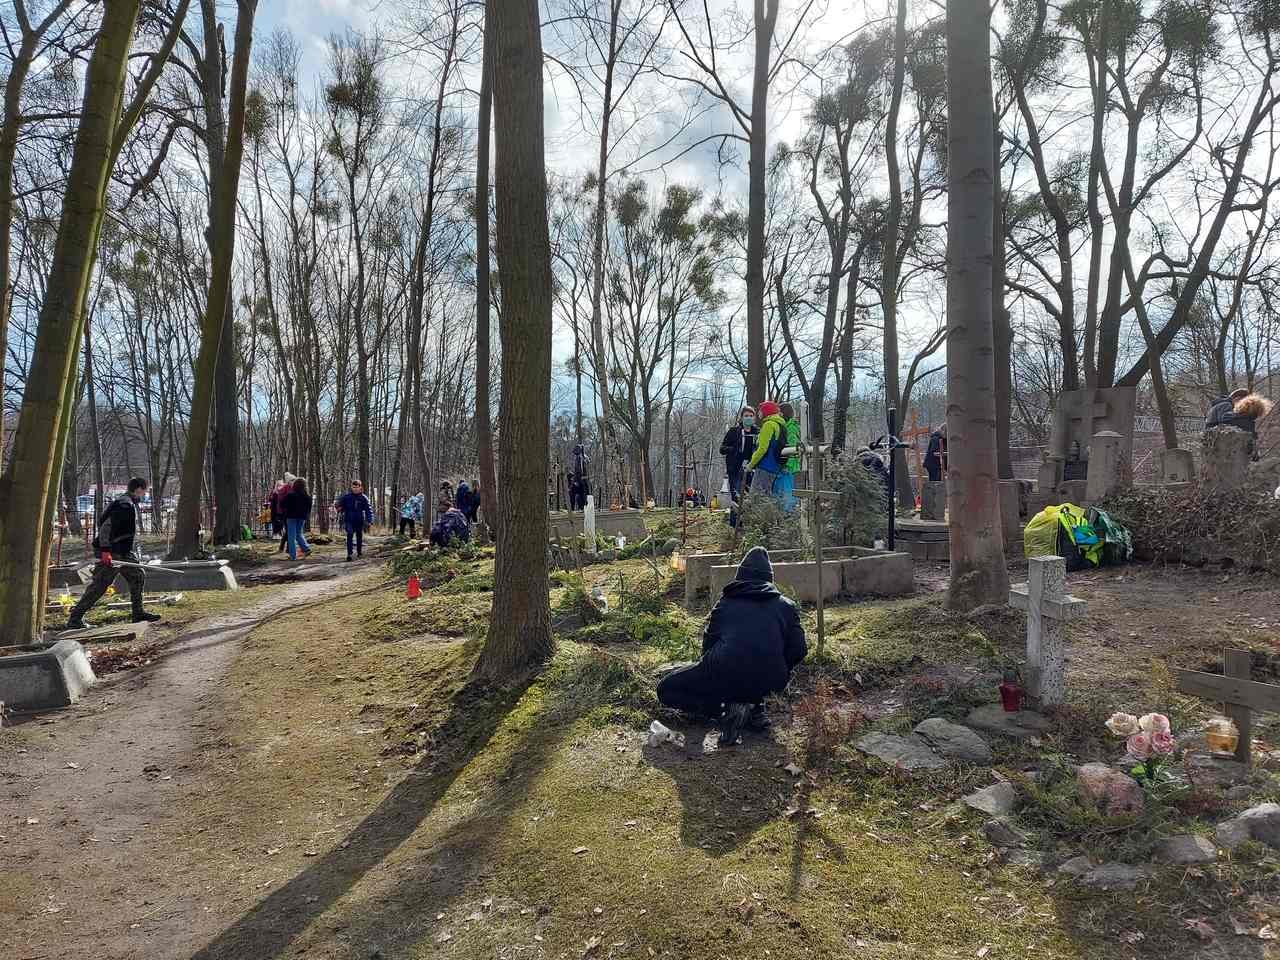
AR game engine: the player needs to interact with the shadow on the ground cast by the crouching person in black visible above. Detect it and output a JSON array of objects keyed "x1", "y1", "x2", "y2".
[{"x1": 644, "y1": 723, "x2": 787, "y2": 856}]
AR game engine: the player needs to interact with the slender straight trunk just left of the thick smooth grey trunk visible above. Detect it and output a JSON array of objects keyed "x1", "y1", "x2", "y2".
[{"x1": 881, "y1": 0, "x2": 914, "y2": 509}]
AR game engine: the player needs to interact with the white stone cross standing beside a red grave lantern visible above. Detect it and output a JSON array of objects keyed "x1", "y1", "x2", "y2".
[{"x1": 1009, "y1": 557, "x2": 1087, "y2": 708}]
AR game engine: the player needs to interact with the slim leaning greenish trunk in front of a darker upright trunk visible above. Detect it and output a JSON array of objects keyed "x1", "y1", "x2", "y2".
[{"x1": 169, "y1": 0, "x2": 257, "y2": 559}]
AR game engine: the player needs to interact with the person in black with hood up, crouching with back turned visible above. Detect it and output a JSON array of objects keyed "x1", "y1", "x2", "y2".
[{"x1": 658, "y1": 547, "x2": 809, "y2": 744}]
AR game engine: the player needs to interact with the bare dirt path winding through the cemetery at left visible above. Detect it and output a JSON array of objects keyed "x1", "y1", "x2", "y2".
[{"x1": 0, "y1": 563, "x2": 369, "y2": 960}]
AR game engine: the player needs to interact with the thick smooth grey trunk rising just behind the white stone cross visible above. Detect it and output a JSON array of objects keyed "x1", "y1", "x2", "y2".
[{"x1": 947, "y1": 0, "x2": 1009, "y2": 611}]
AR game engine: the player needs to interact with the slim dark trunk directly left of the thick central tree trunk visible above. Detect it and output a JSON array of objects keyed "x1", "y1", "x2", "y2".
[{"x1": 475, "y1": 22, "x2": 499, "y2": 529}]
